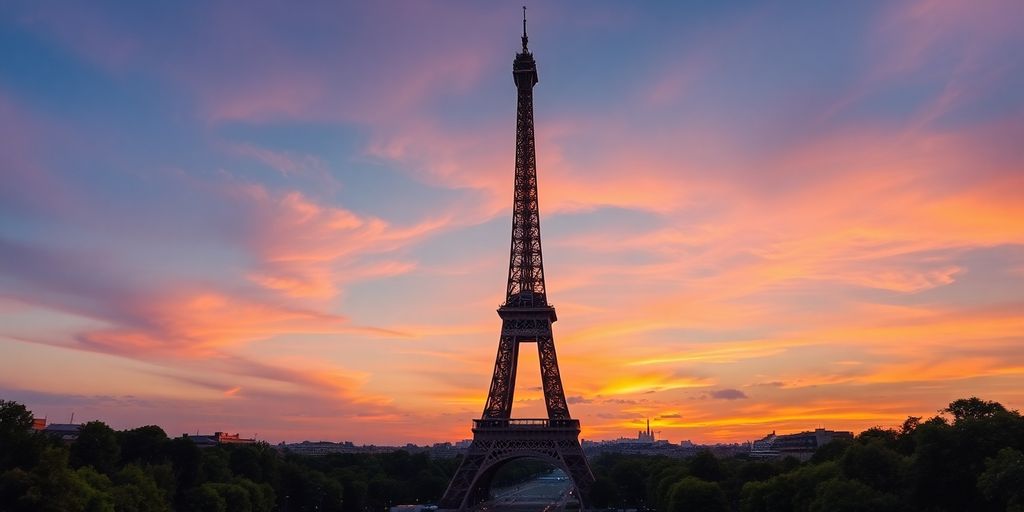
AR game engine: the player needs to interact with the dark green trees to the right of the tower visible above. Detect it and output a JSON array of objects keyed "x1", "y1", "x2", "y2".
[{"x1": 591, "y1": 398, "x2": 1024, "y2": 512}]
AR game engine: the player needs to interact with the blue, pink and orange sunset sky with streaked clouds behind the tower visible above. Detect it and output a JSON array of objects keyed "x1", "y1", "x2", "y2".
[{"x1": 0, "y1": 0, "x2": 1024, "y2": 443}]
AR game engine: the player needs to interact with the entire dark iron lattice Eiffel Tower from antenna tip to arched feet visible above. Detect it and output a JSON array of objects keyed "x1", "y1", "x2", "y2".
[{"x1": 439, "y1": 7, "x2": 594, "y2": 511}]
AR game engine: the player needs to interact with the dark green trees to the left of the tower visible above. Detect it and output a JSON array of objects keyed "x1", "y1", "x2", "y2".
[{"x1": 0, "y1": 400, "x2": 459, "y2": 512}]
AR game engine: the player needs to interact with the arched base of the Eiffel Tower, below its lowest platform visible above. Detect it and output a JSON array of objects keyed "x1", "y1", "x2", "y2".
[{"x1": 438, "y1": 419, "x2": 594, "y2": 512}]
